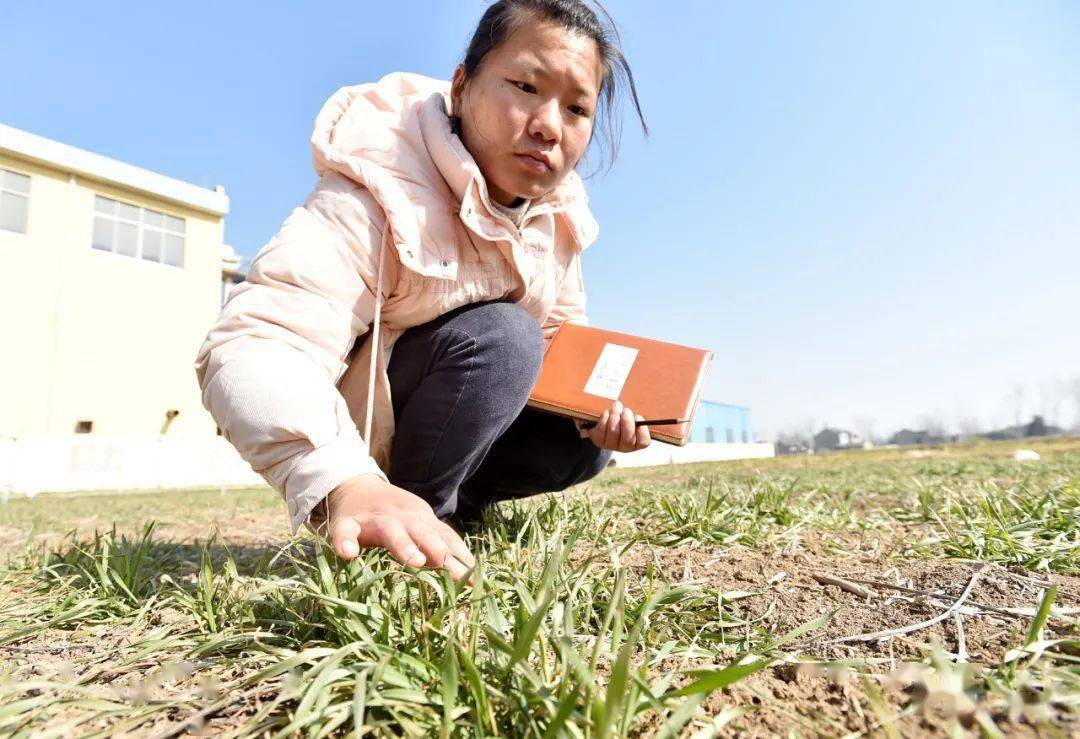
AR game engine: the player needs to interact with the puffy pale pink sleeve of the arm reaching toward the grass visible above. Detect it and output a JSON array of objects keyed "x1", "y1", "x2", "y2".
[{"x1": 195, "y1": 175, "x2": 393, "y2": 532}]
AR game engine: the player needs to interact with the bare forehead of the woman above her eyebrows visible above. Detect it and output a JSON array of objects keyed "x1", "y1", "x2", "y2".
[{"x1": 488, "y1": 19, "x2": 603, "y2": 97}]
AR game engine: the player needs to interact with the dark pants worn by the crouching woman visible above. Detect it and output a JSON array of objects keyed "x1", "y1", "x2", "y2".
[{"x1": 388, "y1": 301, "x2": 611, "y2": 519}]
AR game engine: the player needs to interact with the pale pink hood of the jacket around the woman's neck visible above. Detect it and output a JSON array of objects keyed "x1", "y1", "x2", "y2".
[{"x1": 311, "y1": 72, "x2": 599, "y2": 280}]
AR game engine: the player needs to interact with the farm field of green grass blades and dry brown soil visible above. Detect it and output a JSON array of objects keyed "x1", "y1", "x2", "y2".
[{"x1": 0, "y1": 440, "x2": 1080, "y2": 737}]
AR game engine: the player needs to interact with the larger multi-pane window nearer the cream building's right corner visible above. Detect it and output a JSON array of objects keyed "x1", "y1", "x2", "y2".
[{"x1": 91, "y1": 196, "x2": 185, "y2": 267}]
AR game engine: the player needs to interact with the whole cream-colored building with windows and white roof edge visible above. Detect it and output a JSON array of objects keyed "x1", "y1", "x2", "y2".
[{"x1": 0, "y1": 125, "x2": 242, "y2": 439}]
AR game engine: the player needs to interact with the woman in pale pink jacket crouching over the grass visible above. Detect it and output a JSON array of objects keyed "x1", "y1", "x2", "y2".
[{"x1": 195, "y1": 0, "x2": 649, "y2": 577}]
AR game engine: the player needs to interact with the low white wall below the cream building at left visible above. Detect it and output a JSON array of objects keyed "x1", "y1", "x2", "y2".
[{"x1": 0, "y1": 433, "x2": 267, "y2": 497}]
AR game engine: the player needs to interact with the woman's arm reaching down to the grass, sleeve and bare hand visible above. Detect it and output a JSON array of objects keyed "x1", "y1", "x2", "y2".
[{"x1": 195, "y1": 174, "x2": 475, "y2": 578}]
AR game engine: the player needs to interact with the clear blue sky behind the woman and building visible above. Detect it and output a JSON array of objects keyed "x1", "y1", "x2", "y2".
[{"x1": 0, "y1": 0, "x2": 1080, "y2": 438}]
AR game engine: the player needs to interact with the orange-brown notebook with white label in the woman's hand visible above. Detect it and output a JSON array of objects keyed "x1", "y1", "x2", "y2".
[{"x1": 528, "y1": 323, "x2": 713, "y2": 446}]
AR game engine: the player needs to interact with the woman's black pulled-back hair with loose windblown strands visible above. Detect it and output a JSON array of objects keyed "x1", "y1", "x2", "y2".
[{"x1": 451, "y1": 0, "x2": 649, "y2": 169}]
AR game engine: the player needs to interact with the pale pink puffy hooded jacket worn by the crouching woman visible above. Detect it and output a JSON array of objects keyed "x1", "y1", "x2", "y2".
[{"x1": 195, "y1": 73, "x2": 598, "y2": 532}]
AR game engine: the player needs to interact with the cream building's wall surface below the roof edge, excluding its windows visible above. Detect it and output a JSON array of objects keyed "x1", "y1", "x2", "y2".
[{"x1": 0, "y1": 153, "x2": 225, "y2": 436}]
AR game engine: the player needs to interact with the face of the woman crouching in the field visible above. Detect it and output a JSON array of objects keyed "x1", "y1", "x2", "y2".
[{"x1": 453, "y1": 23, "x2": 602, "y2": 205}]
